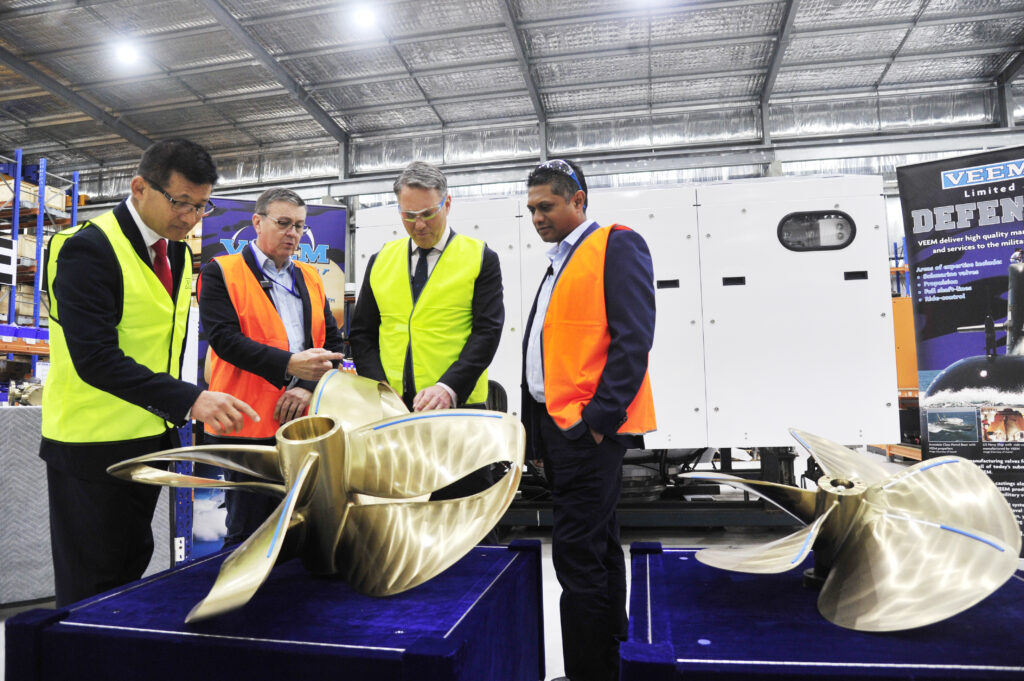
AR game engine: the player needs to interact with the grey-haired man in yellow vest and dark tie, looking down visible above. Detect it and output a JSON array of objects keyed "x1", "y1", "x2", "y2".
[{"x1": 350, "y1": 161, "x2": 505, "y2": 411}]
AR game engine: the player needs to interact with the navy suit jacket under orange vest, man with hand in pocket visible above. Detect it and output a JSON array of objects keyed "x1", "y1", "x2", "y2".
[{"x1": 522, "y1": 222, "x2": 654, "y2": 458}]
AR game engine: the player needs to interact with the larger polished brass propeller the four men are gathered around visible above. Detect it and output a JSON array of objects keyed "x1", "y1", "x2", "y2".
[{"x1": 108, "y1": 372, "x2": 525, "y2": 622}]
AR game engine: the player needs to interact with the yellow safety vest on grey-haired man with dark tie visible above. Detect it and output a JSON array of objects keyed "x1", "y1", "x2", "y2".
[{"x1": 370, "y1": 235, "x2": 487, "y2": 403}]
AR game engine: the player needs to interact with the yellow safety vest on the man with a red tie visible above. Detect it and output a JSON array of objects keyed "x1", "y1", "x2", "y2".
[{"x1": 42, "y1": 212, "x2": 191, "y2": 443}]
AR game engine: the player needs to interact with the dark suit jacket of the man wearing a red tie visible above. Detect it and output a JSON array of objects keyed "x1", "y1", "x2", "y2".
[{"x1": 39, "y1": 200, "x2": 202, "y2": 479}]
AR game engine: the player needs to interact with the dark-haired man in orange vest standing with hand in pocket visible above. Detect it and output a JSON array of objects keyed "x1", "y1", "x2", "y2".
[{"x1": 522, "y1": 160, "x2": 655, "y2": 681}]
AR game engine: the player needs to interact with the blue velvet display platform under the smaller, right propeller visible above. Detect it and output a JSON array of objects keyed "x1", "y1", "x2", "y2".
[{"x1": 621, "y1": 543, "x2": 1024, "y2": 681}]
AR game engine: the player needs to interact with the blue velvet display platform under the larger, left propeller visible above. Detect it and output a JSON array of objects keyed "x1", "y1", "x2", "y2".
[{"x1": 6, "y1": 541, "x2": 544, "y2": 681}]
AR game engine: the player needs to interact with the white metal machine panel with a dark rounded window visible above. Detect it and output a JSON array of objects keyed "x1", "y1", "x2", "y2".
[{"x1": 697, "y1": 176, "x2": 899, "y2": 446}]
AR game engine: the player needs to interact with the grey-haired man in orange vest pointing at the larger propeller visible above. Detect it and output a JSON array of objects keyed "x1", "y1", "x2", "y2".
[{"x1": 199, "y1": 188, "x2": 344, "y2": 546}]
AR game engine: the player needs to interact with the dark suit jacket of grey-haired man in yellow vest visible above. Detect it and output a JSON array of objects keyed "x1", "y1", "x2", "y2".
[{"x1": 349, "y1": 231, "x2": 505, "y2": 405}]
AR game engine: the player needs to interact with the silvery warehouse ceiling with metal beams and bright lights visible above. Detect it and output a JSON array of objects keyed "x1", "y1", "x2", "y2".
[{"x1": 0, "y1": 0, "x2": 1024, "y2": 189}]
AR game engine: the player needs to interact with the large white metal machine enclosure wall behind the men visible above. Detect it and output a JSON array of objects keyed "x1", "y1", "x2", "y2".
[{"x1": 352, "y1": 176, "x2": 899, "y2": 449}]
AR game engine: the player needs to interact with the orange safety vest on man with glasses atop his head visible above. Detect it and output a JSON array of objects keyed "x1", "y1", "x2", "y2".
[{"x1": 543, "y1": 224, "x2": 657, "y2": 435}]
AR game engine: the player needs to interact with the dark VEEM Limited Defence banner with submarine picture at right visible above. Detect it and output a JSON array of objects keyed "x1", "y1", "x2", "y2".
[{"x1": 896, "y1": 146, "x2": 1024, "y2": 540}]
